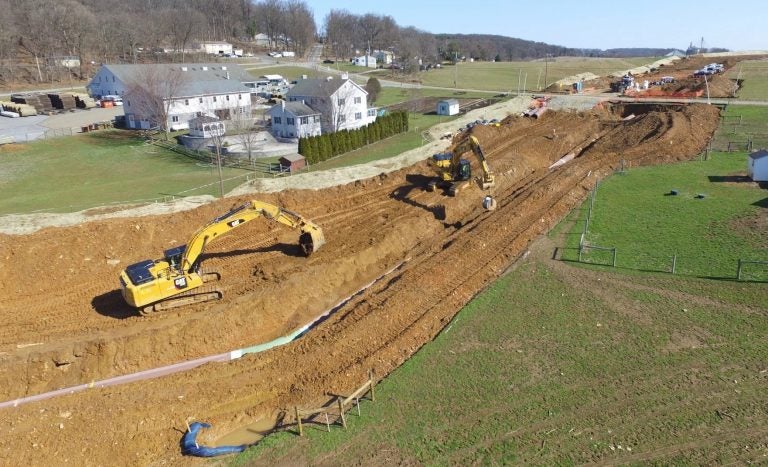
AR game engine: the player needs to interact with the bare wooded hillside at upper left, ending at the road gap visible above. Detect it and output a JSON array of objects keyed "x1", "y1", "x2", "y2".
[{"x1": 0, "y1": 0, "x2": 317, "y2": 83}]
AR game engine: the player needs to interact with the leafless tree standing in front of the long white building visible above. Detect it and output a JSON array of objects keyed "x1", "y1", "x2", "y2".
[{"x1": 123, "y1": 65, "x2": 186, "y2": 139}]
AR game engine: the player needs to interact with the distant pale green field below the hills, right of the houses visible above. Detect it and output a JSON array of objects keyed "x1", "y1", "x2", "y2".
[{"x1": 416, "y1": 57, "x2": 656, "y2": 92}]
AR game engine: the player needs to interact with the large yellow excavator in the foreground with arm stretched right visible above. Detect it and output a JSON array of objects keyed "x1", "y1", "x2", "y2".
[{"x1": 120, "y1": 201, "x2": 325, "y2": 316}]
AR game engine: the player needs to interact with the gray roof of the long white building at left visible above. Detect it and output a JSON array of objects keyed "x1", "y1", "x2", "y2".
[{"x1": 96, "y1": 63, "x2": 256, "y2": 98}]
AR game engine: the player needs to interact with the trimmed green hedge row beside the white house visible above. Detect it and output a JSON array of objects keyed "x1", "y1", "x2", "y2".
[{"x1": 299, "y1": 112, "x2": 408, "y2": 164}]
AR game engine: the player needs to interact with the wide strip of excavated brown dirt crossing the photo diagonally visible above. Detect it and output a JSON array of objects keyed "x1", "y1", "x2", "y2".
[{"x1": 0, "y1": 100, "x2": 719, "y2": 465}]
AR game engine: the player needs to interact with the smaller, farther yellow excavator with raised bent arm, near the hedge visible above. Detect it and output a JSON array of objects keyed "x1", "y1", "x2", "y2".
[{"x1": 427, "y1": 135, "x2": 495, "y2": 196}]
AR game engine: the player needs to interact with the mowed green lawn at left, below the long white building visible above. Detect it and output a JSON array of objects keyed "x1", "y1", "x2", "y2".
[{"x1": 0, "y1": 130, "x2": 246, "y2": 214}]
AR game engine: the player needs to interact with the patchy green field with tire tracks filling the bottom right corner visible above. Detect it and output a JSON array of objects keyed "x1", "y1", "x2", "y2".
[{"x1": 237, "y1": 224, "x2": 768, "y2": 466}]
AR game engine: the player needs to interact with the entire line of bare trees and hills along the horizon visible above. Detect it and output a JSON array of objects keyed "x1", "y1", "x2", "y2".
[{"x1": 0, "y1": 0, "x2": 724, "y2": 83}]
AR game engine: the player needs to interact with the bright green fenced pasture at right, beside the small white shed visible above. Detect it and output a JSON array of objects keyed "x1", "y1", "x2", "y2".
[{"x1": 563, "y1": 152, "x2": 768, "y2": 280}]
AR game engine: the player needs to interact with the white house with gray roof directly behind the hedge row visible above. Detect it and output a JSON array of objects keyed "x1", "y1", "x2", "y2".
[{"x1": 273, "y1": 75, "x2": 376, "y2": 133}]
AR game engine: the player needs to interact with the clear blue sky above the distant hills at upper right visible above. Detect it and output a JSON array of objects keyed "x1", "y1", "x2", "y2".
[{"x1": 307, "y1": 0, "x2": 768, "y2": 50}]
